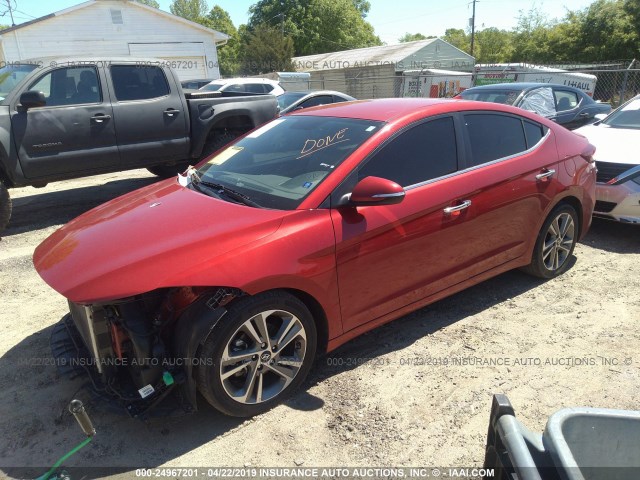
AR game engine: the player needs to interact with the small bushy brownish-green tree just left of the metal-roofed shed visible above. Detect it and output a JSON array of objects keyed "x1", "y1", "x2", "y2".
[{"x1": 241, "y1": 25, "x2": 293, "y2": 75}]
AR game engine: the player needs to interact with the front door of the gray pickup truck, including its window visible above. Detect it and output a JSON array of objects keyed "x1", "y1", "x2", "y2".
[{"x1": 11, "y1": 64, "x2": 120, "y2": 179}]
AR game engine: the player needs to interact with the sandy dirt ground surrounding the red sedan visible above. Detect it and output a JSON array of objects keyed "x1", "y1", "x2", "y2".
[{"x1": 0, "y1": 171, "x2": 640, "y2": 478}]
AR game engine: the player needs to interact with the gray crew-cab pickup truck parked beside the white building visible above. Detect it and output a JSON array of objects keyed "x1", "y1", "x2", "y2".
[{"x1": 0, "y1": 57, "x2": 277, "y2": 231}]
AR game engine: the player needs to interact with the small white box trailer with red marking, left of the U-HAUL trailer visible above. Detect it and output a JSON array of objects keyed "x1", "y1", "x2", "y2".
[{"x1": 402, "y1": 69, "x2": 471, "y2": 98}]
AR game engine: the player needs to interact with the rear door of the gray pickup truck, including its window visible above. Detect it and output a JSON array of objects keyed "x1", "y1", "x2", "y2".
[{"x1": 107, "y1": 64, "x2": 189, "y2": 168}]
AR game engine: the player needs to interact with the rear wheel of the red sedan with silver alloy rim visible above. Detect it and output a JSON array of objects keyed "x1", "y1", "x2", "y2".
[{"x1": 523, "y1": 204, "x2": 579, "y2": 279}]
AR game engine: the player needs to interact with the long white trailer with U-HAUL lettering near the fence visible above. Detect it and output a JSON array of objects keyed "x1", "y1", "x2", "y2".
[{"x1": 473, "y1": 63, "x2": 598, "y2": 97}]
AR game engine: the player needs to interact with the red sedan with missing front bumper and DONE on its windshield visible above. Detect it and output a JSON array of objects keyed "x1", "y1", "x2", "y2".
[{"x1": 34, "y1": 99, "x2": 596, "y2": 416}]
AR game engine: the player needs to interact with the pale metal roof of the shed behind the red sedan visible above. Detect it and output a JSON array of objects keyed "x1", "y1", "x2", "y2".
[{"x1": 292, "y1": 38, "x2": 456, "y2": 71}]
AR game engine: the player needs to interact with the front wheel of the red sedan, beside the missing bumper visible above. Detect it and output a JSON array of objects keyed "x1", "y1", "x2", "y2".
[{"x1": 196, "y1": 291, "x2": 317, "y2": 417}]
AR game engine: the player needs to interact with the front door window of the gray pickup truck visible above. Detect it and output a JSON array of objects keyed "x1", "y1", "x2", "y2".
[{"x1": 29, "y1": 67, "x2": 102, "y2": 107}]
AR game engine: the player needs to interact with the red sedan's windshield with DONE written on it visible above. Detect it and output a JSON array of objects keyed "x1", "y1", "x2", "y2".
[{"x1": 198, "y1": 115, "x2": 383, "y2": 210}]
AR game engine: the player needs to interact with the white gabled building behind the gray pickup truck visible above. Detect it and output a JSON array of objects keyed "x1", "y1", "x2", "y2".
[{"x1": 0, "y1": 0, "x2": 229, "y2": 80}]
